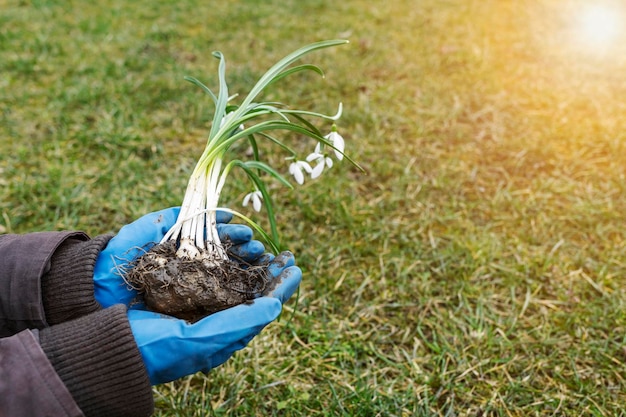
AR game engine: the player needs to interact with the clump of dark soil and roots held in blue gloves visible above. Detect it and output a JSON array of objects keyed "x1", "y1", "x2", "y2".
[{"x1": 126, "y1": 242, "x2": 268, "y2": 322}]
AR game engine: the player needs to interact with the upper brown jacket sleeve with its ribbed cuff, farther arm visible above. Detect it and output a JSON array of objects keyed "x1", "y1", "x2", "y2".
[{"x1": 0, "y1": 232, "x2": 111, "y2": 337}]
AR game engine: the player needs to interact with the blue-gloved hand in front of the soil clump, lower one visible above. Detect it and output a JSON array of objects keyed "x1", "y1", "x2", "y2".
[{"x1": 128, "y1": 252, "x2": 302, "y2": 385}]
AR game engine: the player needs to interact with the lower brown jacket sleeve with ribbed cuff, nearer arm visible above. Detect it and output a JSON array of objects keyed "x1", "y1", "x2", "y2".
[{"x1": 0, "y1": 305, "x2": 153, "y2": 417}]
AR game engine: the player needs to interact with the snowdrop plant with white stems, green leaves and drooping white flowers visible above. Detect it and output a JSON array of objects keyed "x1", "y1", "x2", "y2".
[{"x1": 161, "y1": 40, "x2": 358, "y2": 262}]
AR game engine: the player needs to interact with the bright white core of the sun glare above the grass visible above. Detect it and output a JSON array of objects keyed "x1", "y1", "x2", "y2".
[{"x1": 579, "y1": 5, "x2": 624, "y2": 47}]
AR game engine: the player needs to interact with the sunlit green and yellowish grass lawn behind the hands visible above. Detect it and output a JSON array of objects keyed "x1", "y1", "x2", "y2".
[{"x1": 0, "y1": 0, "x2": 626, "y2": 416}]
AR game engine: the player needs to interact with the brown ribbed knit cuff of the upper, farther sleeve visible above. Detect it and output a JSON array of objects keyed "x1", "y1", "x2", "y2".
[{"x1": 41, "y1": 235, "x2": 113, "y2": 325}]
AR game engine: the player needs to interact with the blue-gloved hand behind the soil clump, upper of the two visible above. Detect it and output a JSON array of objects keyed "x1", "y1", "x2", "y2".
[{"x1": 94, "y1": 207, "x2": 265, "y2": 308}]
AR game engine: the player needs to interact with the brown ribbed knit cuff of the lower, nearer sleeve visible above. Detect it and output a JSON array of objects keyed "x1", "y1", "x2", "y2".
[{"x1": 39, "y1": 304, "x2": 154, "y2": 417}]
